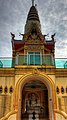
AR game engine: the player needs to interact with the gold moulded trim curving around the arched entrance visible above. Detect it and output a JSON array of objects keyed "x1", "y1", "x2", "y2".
[{"x1": 14, "y1": 72, "x2": 57, "y2": 120}]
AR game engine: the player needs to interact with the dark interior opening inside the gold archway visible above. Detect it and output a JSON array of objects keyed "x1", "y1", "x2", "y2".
[{"x1": 21, "y1": 80, "x2": 49, "y2": 120}]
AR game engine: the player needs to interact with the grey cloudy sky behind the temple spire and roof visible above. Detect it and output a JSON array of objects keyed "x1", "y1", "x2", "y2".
[{"x1": 0, "y1": 0, "x2": 67, "y2": 58}]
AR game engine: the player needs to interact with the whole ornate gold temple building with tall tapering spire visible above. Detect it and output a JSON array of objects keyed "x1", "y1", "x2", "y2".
[{"x1": 0, "y1": 0, "x2": 67, "y2": 120}]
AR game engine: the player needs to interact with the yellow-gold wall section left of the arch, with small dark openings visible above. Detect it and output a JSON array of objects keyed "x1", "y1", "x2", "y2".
[{"x1": 0, "y1": 68, "x2": 15, "y2": 118}]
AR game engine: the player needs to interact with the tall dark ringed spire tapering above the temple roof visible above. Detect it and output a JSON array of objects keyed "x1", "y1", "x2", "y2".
[{"x1": 25, "y1": 0, "x2": 41, "y2": 33}]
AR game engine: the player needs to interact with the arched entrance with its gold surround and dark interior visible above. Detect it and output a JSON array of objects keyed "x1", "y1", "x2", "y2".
[{"x1": 15, "y1": 74, "x2": 56, "y2": 120}]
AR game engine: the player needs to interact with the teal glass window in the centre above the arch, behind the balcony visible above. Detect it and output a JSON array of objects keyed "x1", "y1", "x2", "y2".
[{"x1": 28, "y1": 52, "x2": 41, "y2": 65}]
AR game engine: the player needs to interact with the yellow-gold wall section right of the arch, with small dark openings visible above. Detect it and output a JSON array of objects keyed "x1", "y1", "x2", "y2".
[{"x1": 56, "y1": 69, "x2": 67, "y2": 113}]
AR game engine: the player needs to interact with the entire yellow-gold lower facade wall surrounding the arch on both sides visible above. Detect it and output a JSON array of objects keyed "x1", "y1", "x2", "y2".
[{"x1": 0, "y1": 66, "x2": 67, "y2": 118}]
